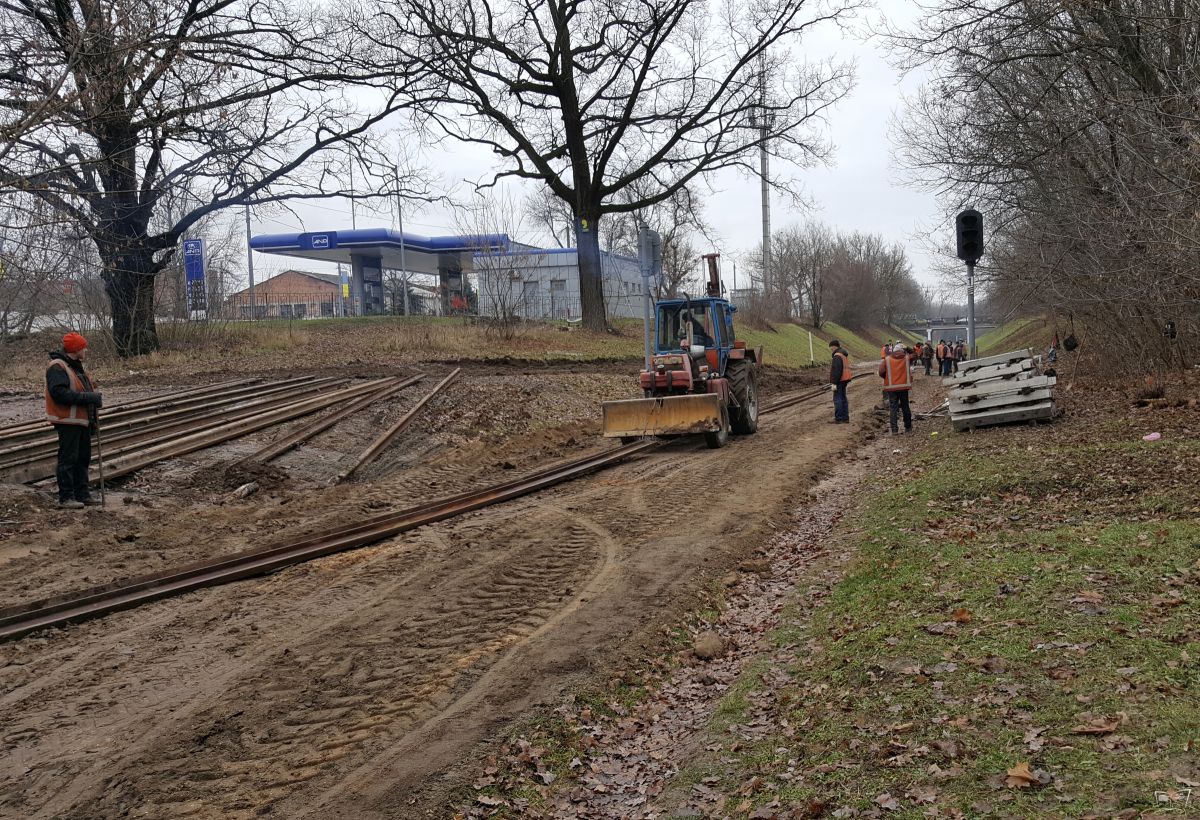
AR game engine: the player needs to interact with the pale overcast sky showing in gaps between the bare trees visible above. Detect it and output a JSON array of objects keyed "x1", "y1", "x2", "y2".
[{"x1": 252, "y1": 0, "x2": 937, "y2": 291}]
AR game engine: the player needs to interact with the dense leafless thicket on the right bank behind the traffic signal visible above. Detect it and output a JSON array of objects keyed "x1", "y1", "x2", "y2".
[{"x1": 895, "y1": 0, "x2": 1200, "y2": 369}]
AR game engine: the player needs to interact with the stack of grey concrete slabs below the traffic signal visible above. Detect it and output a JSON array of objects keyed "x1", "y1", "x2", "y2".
[{"x1": 942, "y1": 349, "x2": 1057, "y2": 431}]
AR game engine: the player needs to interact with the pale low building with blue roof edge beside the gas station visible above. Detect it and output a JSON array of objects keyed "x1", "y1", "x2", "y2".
[{"x1": 474, "y1": 244, "x2": 642, "y2": 319}]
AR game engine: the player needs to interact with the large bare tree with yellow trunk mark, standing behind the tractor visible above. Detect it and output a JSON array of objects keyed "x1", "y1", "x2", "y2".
[{"x1": 365, "y1": 0, "x2": 859, "y2": 330}]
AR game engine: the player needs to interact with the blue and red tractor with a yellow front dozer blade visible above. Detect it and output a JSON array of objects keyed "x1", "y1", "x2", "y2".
[{"x1": 602, "y1": 253, "x2": 762, "y2": 448}]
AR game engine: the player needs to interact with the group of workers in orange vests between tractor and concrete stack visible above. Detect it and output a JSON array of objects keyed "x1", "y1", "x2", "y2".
[{"x1": 829, "y1": 339, "x2": 966, "y2": 436}]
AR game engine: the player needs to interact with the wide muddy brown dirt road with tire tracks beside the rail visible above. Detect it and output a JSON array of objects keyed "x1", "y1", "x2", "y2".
[{"x1": 0, "y1": 379, "x2": 878, "y2": 818}]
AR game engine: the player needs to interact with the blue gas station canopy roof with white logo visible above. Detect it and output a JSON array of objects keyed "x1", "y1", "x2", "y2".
[{"x1": 250, "y1": 228, "x2": 509, "y2": 274}]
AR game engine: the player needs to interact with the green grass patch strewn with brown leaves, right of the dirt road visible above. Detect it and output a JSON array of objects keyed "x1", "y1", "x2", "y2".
[{"x1": 688, "y1": 418, "x2": 1200, "y2": 818}]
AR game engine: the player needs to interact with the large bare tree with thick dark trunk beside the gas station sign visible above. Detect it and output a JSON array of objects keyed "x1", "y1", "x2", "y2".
[{"x1": 0, "y1": 0, "x2": 420, "y2": 355}]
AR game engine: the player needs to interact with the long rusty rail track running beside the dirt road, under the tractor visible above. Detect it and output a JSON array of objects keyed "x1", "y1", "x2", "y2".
[{"x1": 0, "y1": 373, "x2": 866, "y2": 641}]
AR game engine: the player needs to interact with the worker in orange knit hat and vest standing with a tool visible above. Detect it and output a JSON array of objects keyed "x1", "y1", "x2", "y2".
[{"x1": 46, "y1": 333, "x2": 102, "y2": 509}]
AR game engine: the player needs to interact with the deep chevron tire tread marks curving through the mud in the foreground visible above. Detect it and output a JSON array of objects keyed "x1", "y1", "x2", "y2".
[{"x1": 49, "y1": 505, "x2": 614, "y2": 816}]
